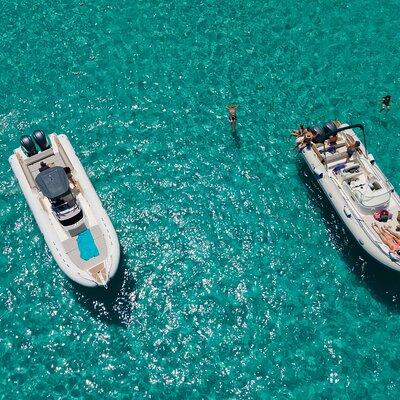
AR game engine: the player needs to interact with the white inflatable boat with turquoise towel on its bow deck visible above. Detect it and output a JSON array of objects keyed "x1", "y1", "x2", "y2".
[{"x1": 9, "y1": 131, "x2": 120, "y2": 287}]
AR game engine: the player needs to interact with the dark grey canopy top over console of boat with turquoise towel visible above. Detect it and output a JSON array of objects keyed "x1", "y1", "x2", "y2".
[{"x1": 35, "y1": 167, "x2": 69, "y2": 199}]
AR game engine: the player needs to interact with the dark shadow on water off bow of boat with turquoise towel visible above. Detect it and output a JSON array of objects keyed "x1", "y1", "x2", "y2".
[{"x1": 72, "y1": 249, "x2": 136, "y2": 327}]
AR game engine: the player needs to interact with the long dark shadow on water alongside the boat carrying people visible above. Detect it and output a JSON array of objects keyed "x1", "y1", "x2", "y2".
[{"x1": 297, "y1": 160, "x2": 400, "y2": 312}]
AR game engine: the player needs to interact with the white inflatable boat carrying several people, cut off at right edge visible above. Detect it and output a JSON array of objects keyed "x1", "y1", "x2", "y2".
[{"x1": 298, "y1": 121, "x2": 400, "y2": 271}]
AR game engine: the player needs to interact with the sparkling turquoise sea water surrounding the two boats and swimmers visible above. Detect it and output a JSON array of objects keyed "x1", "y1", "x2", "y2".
[{"x1": 0, "y1": 0, "x2": 400, "y2": 399}]
